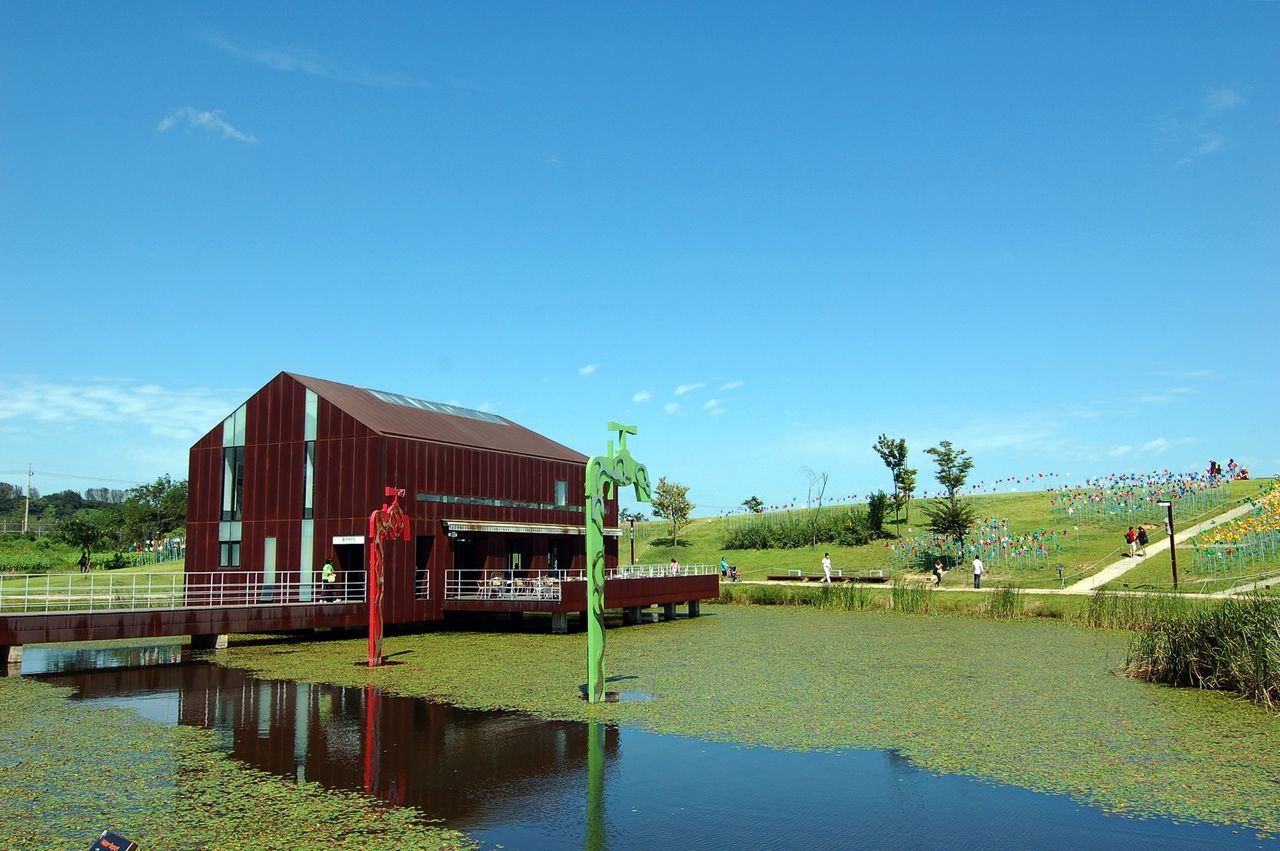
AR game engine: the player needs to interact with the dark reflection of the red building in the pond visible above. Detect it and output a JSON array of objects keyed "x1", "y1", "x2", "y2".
[{"x1": 47, "y1": 663, "x2": 620, "y2": 824}]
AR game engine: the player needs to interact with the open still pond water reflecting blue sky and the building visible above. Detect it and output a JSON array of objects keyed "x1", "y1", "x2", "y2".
[{"x1": 23, "y1": 648, "x2": 1280, "y2": 851}]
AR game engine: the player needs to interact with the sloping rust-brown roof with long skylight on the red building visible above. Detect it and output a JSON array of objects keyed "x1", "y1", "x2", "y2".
[{"x1": 284, "y1": 372, "x2": 586, "y2": 463}]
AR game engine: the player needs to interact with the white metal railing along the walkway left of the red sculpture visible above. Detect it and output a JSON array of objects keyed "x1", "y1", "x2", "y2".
[{"x1": 0, "y1": 571, "x2": 366, "y2": 614}]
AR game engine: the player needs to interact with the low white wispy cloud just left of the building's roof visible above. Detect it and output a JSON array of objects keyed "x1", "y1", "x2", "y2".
[{"x1": 0, "y1": 378, "x2": 239, "y2": 441}]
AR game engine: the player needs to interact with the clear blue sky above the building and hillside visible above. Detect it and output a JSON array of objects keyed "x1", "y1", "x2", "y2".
[{"x1": 0, "y1": 3, "x2": 1280, "y2": 513}]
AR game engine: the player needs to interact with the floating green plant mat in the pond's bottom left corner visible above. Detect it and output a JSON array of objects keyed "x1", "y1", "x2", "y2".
[{"x1": 0, "y1": 677, "x2": 472, "y2": 851}]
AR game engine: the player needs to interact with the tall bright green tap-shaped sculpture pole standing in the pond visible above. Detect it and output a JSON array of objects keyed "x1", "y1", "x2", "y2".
[{"x1": 586, "y1": 422, "x2": 650, "y2": 704}]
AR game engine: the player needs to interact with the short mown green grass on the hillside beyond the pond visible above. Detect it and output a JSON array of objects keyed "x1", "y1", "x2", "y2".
[{"x1": 621, "y1": 479, "x2": 1280, "y2": 587}]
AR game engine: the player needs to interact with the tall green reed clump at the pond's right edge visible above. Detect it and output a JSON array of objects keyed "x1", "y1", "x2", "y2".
[{"x1": 1125, "y1": 596, "x2": 1280, "y2": 709}]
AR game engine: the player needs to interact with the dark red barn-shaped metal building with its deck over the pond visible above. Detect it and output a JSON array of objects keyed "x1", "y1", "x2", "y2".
[{"x1": 187, "y1": 372, "x2": 717, "y2": 630}]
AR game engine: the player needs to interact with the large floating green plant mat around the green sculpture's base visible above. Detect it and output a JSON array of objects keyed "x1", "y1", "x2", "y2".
[{"x1": 218, "y1": 605, "x2": 1280, "y2": 833}]
